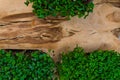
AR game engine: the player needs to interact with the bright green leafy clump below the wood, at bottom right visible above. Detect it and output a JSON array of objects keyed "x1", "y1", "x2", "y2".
[{"x1": 58, "y1": 47, "x2": 120, "y2": 80}]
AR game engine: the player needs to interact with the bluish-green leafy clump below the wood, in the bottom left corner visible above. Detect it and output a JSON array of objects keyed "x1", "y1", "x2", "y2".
[{"x1": 0, "y1": 50, "x2": 55, "y2": 80}]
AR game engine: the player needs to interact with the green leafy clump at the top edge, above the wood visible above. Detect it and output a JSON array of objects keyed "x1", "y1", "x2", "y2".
[{"x1": 25, "y1": 0, "x2": 94, "y2": 18}]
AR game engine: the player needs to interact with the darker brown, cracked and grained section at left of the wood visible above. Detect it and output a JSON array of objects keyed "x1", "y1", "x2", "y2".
[{"x1": 0, "y1": 13, "x2": 64, "y2": 45}]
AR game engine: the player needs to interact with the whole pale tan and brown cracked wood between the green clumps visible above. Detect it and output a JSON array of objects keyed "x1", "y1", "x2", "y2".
[{"x1": 0, "y1": 0, "x2": 120, "y2": 59}]
